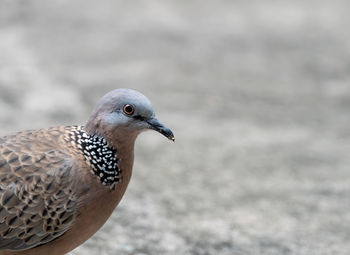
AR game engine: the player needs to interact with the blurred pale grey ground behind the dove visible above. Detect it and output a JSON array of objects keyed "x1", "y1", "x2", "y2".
[{"x1": 0, "y1": 0, "x2": 350, "y2": 255}]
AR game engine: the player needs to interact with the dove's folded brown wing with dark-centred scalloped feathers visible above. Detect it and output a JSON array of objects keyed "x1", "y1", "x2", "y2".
[{"x1": 0, "y1": 131, "x2": 77, "y2": 251}]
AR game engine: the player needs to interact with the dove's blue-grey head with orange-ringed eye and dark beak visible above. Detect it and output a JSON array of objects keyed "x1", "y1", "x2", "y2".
[{"x1": 85, "y1": 89, "x2": 175, "y2": 145}]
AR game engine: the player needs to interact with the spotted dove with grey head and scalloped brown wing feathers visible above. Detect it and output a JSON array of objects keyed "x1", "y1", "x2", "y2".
[{"x1": 0, "y1": 89, "x2": 175, "y2": 255}]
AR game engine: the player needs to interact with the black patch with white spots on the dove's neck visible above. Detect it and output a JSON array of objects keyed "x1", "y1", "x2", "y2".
[{"x1": 67, "y1": 126, "x2": 121, "y2": 187}]
